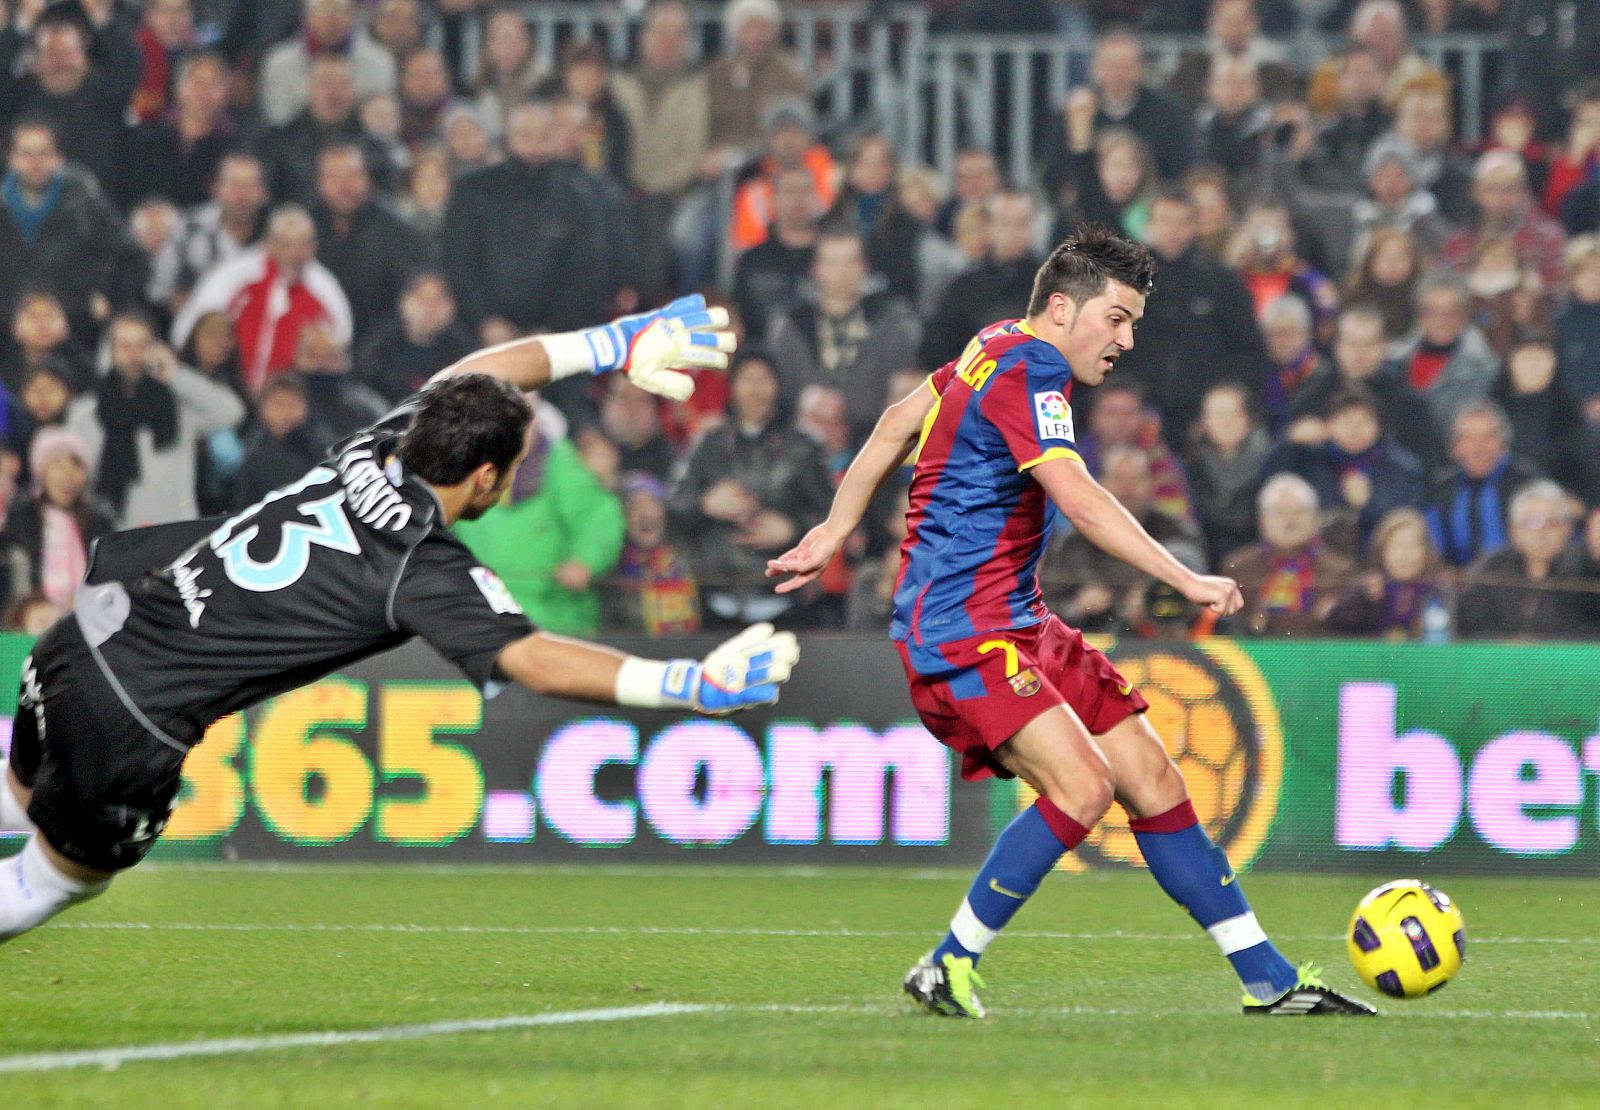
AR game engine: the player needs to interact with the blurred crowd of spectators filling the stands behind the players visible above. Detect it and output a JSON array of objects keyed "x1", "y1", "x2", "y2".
[{"x1": 0, "y1": 0, "x2": 1600, "y2": 638}]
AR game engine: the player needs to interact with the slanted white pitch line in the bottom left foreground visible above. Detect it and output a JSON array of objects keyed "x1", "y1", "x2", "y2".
[{"x1": 0, "y1": 1003, "x2": 715, "y2": 1072}]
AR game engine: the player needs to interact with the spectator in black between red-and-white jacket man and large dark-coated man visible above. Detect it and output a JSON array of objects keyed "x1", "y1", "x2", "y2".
[{"x1": 312, "y1": 142, "x2": 427, "y2": 342}]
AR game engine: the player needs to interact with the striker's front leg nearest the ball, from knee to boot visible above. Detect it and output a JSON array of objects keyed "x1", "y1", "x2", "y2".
[{"x1": 1094, "y1": 713, "x2": 1374, "y2": 1014}]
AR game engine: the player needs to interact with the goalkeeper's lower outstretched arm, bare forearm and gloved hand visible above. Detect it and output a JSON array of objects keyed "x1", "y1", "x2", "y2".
[{"x1": 496, "y1": 624, "x2": 800, "y2": 715}]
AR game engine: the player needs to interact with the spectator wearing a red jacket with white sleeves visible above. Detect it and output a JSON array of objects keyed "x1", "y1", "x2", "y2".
[{"x1": 171, "y1": 205, "x2": 352, "y2": 395}]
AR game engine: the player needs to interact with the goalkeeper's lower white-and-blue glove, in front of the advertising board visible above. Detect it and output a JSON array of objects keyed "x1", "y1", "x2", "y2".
[{"x1": 616, "y1": 624, "x2": 800, "y2": 717}]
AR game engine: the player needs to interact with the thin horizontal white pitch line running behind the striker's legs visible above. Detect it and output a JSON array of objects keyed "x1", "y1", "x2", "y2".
[{"x1": 50, "y1": 921, "x2": 1600, "y2": 945}]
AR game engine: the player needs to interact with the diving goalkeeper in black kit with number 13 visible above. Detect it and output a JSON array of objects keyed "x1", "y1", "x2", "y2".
[{"x1": 0, "y1": 297, "x2": 798, "y2": 940}]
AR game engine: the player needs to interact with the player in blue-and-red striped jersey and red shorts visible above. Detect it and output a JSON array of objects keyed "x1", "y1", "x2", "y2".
[{"x1": 768, "y1": 227, "x2": 1374, "y2": 1017}]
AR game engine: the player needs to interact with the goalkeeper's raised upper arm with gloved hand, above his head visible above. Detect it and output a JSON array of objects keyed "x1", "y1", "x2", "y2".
[{"x1": 435, "y1": 293, "x2": 734, "y2": 401}]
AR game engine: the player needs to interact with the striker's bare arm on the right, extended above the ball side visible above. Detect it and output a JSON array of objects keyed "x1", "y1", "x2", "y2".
[{"x1": 1030, "y1": 457, "x2": 1245, "y2": 616}]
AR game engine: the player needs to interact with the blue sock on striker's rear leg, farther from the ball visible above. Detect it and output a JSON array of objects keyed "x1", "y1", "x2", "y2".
[{"x1": 933, "y1": 798, "x2": 1090, "y2": 964}]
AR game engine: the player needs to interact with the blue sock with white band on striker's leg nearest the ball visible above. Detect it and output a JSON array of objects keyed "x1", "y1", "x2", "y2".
[{"x1": 1130, "y1": 800, "x2": 1296, "y2": 1000}]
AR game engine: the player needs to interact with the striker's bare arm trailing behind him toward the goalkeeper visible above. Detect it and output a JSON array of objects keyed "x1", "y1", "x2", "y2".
[{"x1": 766, "y1": 384, "x2": 938, "y2": 593}]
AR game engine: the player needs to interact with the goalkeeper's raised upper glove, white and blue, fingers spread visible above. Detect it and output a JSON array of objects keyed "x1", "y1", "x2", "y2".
[{"x1": 578, "y1": 293, "x2": 734, "y2": 401}]
